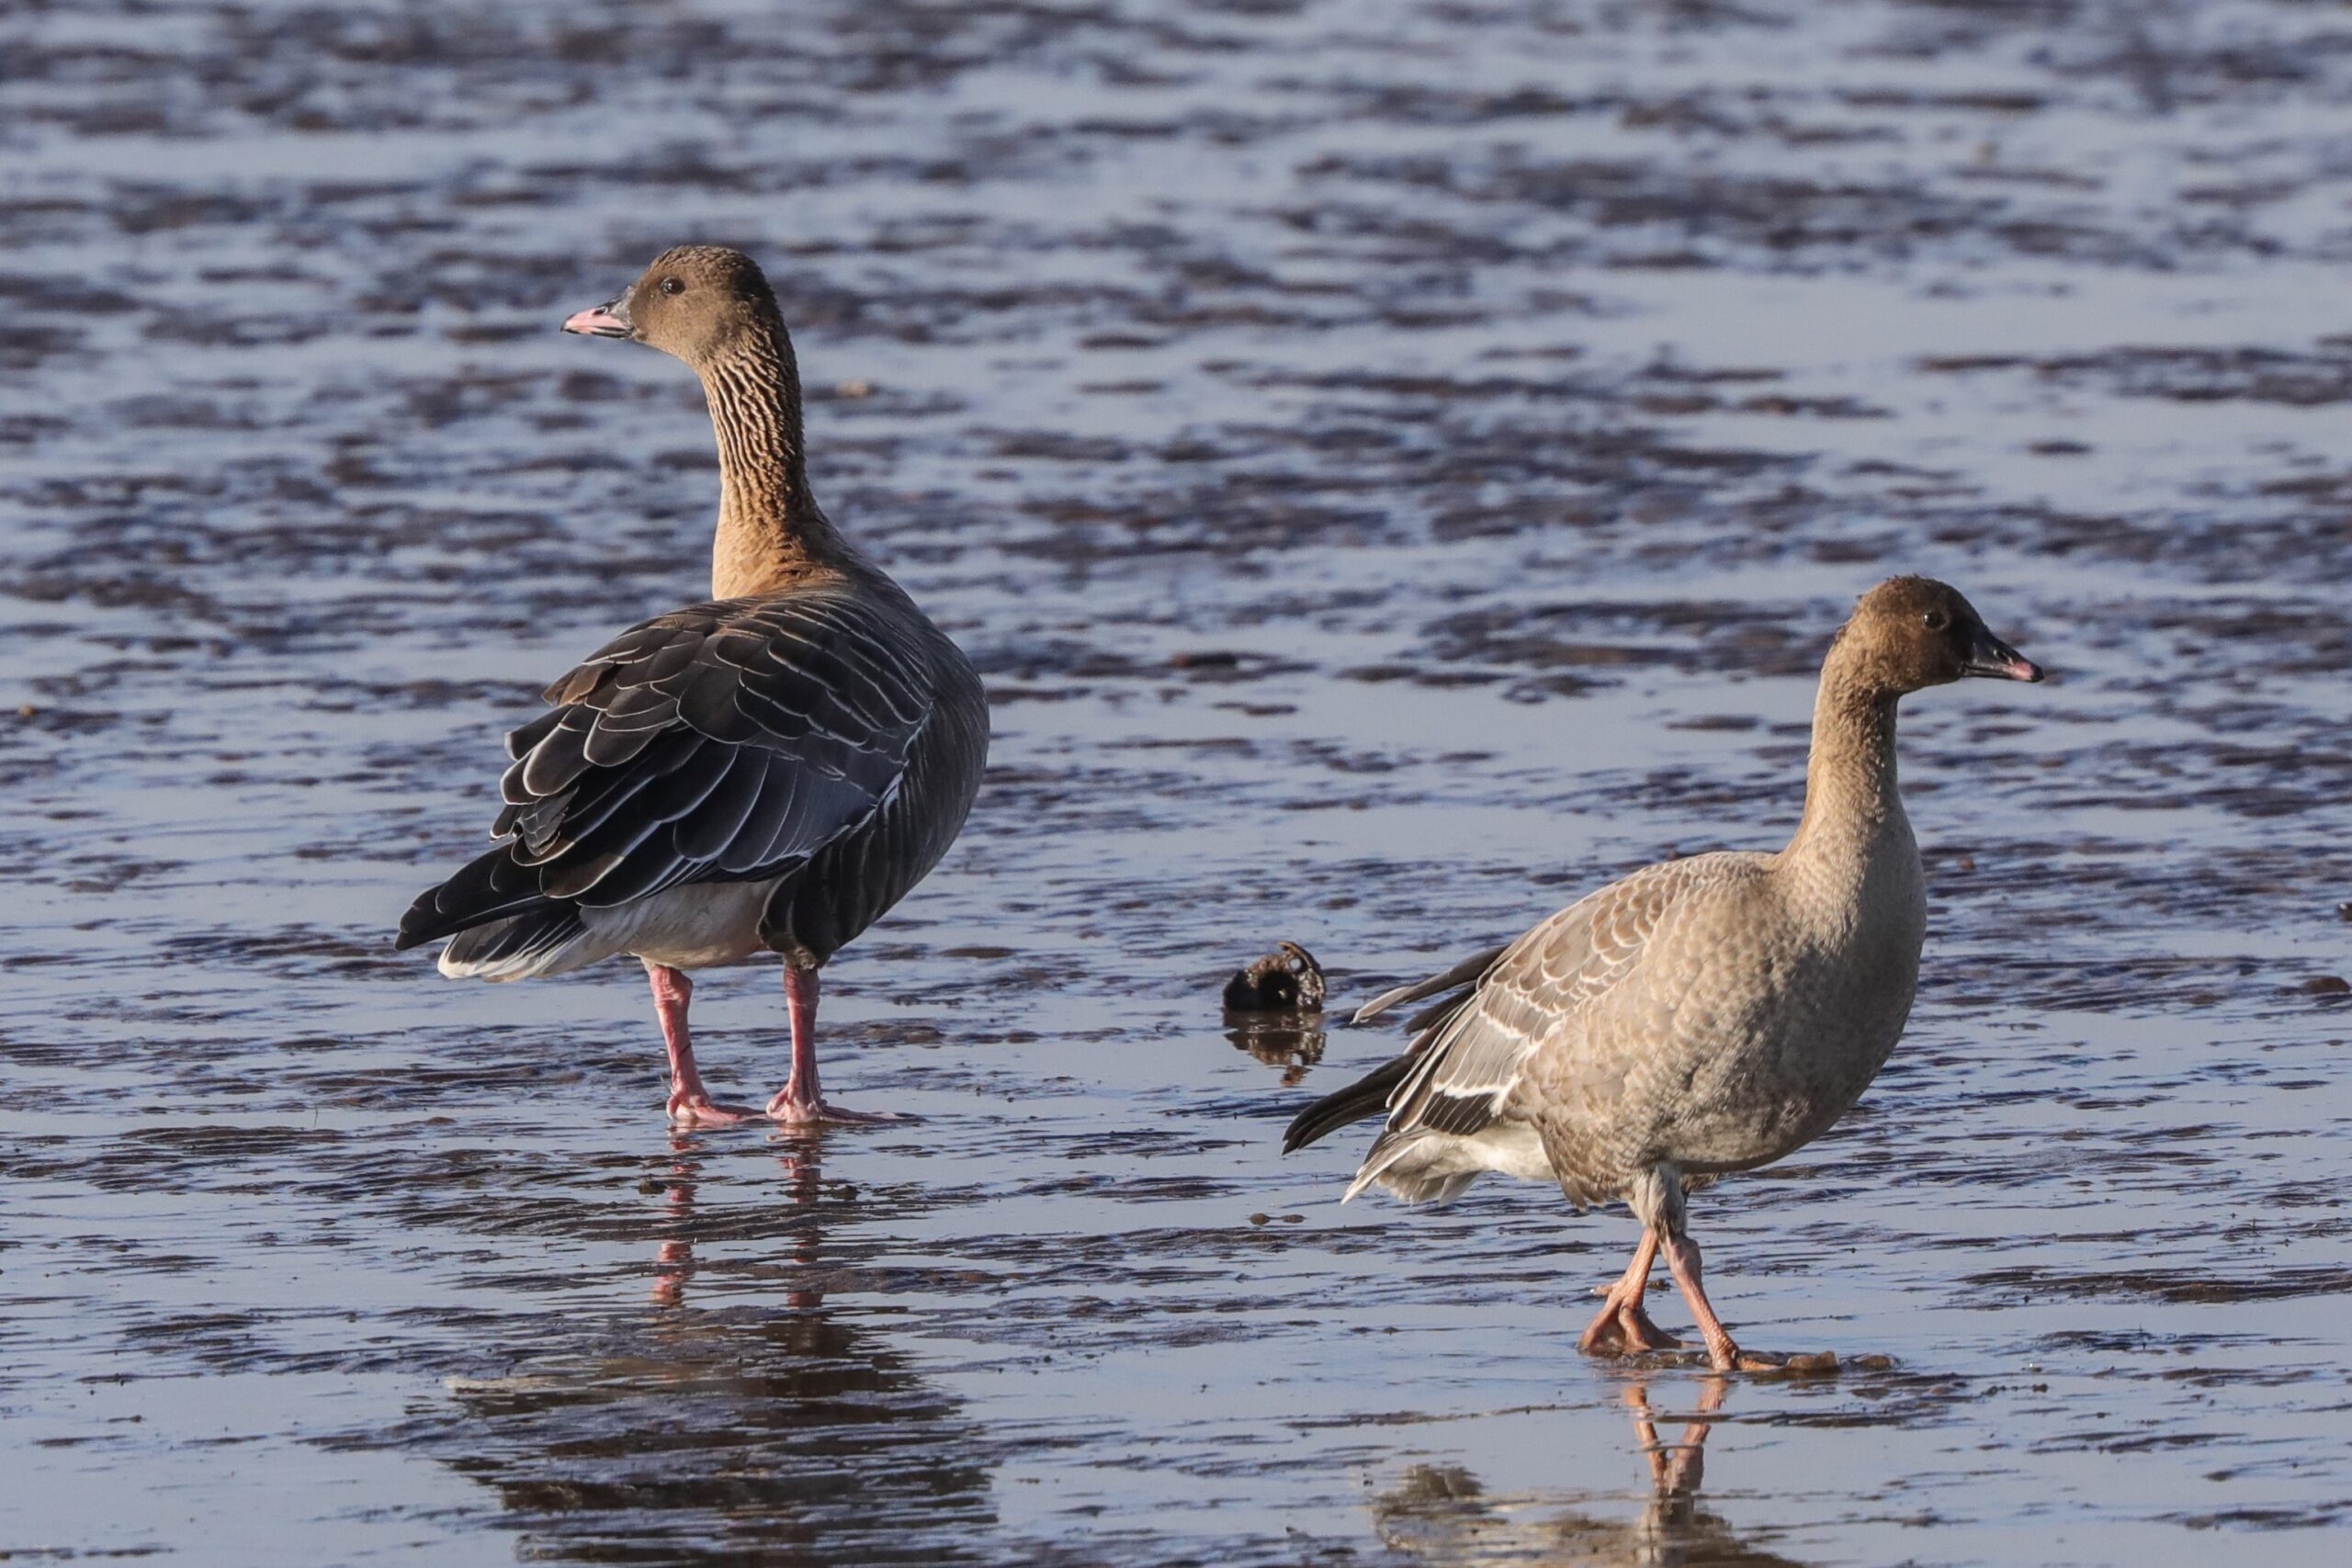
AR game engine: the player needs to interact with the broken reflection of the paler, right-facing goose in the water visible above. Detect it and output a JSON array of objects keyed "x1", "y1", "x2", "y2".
[{"x1": 1374, "y1": 1378, "x2": 1797, "y2": 1568}]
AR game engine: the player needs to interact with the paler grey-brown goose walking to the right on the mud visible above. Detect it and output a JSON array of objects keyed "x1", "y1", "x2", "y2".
[{"x1": 1282, "y1": 576, "x2": 2041, "y2": 1371}]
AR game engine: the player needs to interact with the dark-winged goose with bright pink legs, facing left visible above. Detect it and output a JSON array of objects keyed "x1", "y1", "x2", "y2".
[{"x1": 400, "y1": 244, "x2": 988, "y2": 1126}]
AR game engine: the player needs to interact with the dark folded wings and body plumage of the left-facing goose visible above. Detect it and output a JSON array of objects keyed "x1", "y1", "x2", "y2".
[{"x1": 400, "y1": 573, "x2": 988, "y2": 974}]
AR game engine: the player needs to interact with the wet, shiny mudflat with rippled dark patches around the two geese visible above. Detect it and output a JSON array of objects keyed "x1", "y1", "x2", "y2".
[{"x1": 0, "y1": 0, "x2": 2352, "y2": 1565}]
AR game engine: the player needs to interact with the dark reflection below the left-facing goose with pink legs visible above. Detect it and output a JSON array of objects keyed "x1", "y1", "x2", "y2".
[{"x1": 439, "y1": 1138, "x2": 1002, "y2": 1565}]
